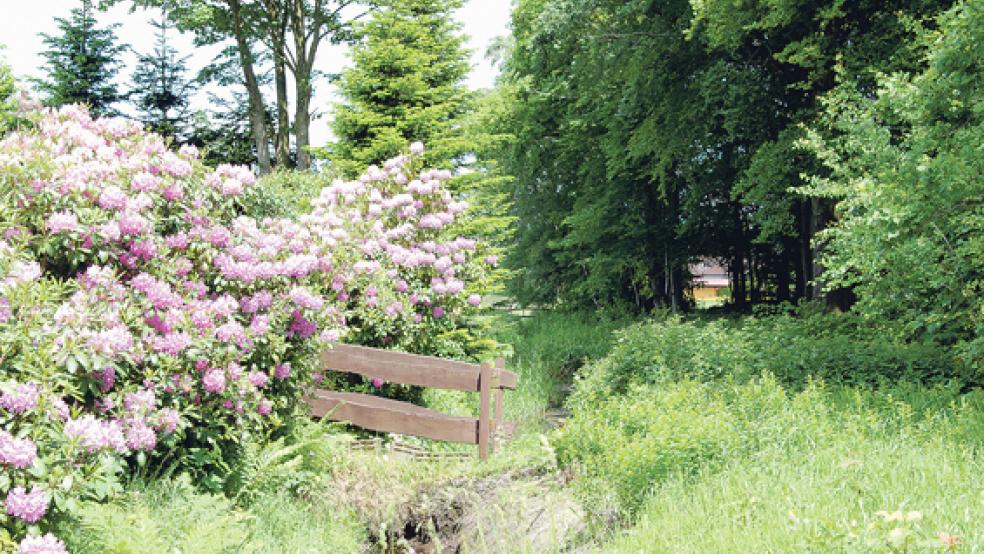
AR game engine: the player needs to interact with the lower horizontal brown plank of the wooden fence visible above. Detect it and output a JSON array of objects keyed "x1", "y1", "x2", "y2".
[{"x1": 306, "y1": 390, "x2": 478, "y2": 444}]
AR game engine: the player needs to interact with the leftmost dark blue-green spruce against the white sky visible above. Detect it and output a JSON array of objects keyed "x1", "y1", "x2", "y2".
[{"x1": 37, "y1": 0, "x2": 127, "y2": 116}]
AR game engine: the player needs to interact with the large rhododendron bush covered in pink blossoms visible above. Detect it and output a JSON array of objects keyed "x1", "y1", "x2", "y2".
[{"x1": 0, "y1": 106, "x2": 494, "y2": 553}]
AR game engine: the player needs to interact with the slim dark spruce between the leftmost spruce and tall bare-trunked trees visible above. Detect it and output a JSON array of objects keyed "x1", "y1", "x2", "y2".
[{"x1": 131, "y1": 15, "x2": 196, "y2": 140}]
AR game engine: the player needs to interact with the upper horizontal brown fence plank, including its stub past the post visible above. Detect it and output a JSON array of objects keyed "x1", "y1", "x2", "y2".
[{"x1": 321, "y1": 344, "x2": 518, "y2": 391}]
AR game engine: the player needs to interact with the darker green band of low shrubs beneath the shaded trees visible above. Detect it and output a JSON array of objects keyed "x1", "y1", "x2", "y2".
[{"x1": 575, "y1": 314, "x2": 966, "y2": 396}]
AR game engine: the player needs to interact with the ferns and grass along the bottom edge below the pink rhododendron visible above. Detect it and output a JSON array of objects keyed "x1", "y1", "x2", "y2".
[{"x1": 53, "y1": 470, "x2": 365, "y2": 554}]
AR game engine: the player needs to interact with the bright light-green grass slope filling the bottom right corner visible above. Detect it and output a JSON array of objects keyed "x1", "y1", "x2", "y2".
[{"x1": 605, "y1": 382, "x2": 984, "y2": 553}]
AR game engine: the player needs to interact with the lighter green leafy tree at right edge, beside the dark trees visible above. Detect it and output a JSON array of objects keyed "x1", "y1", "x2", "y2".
[{"x1": 805, "y1": 2, "x2": 984, "y2": 374}]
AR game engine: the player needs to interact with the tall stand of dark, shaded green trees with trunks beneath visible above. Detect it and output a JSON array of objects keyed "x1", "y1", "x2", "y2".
[{"x1": 496, "y1": 0, "x2": 951, "y2": 310}]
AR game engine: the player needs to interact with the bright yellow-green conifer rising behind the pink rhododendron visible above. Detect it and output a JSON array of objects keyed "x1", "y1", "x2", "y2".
[{"x1": 328, "y1": 0, "x2": 472, "y2": 176}]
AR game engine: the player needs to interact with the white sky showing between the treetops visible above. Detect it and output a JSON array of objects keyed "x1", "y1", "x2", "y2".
[{"x1": 0, "y1": 0, "x2": 511, "y2": 145}]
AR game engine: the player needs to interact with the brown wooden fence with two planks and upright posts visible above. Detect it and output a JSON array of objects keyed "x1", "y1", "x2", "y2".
[{"x1": 306, "y1": 344, "x2": 519, "y2": 460}]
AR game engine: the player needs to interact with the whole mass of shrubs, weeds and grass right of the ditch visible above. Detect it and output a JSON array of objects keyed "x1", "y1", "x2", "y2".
[{"x1": 551, "y1": 313, "x2": 984, "y2": 553}]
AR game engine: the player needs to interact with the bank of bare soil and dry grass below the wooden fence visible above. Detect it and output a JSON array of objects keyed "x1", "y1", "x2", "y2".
[{"x1": 332, "y1": 453, "x2": 586, "y2": 554}]
